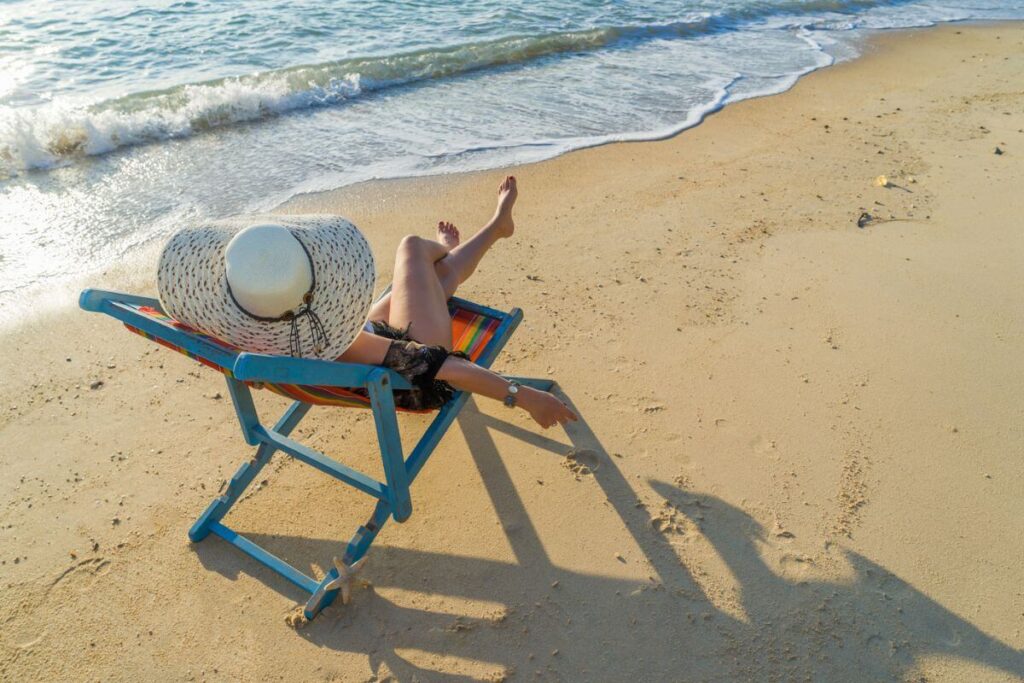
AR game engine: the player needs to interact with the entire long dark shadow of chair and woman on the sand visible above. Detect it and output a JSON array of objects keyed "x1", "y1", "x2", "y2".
[{"x1": 196, "y1": 394, "x2": 1024, "y2": 681}]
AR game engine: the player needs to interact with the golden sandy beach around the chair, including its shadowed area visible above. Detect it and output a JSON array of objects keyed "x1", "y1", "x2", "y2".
[{"x1": 0, "y1": 24, "x2": 1024, "y2": 681}]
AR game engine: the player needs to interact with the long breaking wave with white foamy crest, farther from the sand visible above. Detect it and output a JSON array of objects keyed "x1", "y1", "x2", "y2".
[{"x1": 0, "y1": 0, "x2": 913, "y2": 178}]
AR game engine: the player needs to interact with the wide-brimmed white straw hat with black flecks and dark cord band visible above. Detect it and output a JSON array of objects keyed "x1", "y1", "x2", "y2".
[{"x1": 157, "y1": 215, "x2": 376, "y2": 359}]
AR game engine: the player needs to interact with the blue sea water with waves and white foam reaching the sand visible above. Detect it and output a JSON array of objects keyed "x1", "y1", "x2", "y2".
[{"x1": 0, "y1": 0, "x2": 1024, "y2": 323}]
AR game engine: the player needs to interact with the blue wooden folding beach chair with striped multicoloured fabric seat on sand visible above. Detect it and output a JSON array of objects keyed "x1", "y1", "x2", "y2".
[{"x1": 79, "y1": 290, "x2": 554, "y2": 618}]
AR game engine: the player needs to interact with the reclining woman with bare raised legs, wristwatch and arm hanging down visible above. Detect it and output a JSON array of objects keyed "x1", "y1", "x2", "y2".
[{"x1": 341, "y1": 175, "x2": 577, "y2": 429}]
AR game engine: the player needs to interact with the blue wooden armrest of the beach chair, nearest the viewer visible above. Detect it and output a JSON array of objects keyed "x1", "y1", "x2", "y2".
[{"x1": 231, "y1": 353, "x2": 413, "y2": 389}]
